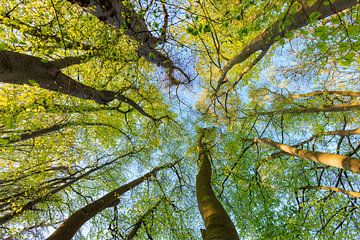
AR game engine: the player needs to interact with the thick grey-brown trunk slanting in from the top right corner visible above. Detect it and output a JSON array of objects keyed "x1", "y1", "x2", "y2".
[{"x1": 215, "y1": 0, "x2": 357, "y2": 92}]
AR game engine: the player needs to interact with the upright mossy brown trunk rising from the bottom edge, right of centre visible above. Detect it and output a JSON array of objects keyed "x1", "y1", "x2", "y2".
[{"x1": 196, "y1": 130, "x2": 239, "y2": 240}]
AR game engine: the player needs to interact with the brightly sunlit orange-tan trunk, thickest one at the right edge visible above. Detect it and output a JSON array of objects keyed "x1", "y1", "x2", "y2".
[{"x1": 253, "y1": 138, "x2": 360, "y2": 173}]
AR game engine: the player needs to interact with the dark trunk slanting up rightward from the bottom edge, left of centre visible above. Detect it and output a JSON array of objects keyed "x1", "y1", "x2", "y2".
[{"x1": 47, "y1": 161, "x2": 178, "y2": 240}]
